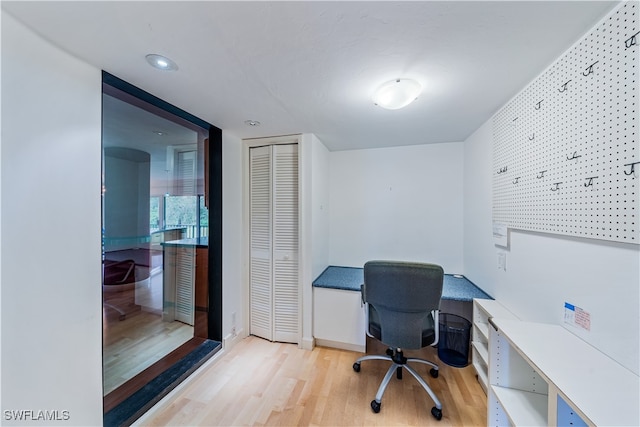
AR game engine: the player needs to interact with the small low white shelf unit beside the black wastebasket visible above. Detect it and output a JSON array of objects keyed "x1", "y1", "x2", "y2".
[{"x1": 471, "y1": 298, "x2": 516, "y2": 393}]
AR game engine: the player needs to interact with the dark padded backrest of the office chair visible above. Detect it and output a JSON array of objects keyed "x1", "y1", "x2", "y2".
[{"x1": 362, "y1": 261, "x2": 444, "y2": 349}]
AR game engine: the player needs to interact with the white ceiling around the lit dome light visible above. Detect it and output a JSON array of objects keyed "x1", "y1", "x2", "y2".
[{"x1": 2, "y1": 1, "x2": 617, "y2": 150}]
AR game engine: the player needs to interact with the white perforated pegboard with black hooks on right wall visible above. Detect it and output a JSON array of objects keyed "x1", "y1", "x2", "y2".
[{"x1": 493, "y1": 1, "x2": 640, "y2": 244}]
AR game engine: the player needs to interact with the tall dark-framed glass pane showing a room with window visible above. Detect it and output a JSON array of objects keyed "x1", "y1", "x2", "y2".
[{"x1": 102, "y1": 85, "x2": 208, "y2": 395}]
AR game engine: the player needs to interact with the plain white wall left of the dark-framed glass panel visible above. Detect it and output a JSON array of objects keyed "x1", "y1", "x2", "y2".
[{"x1": 0, "y1": 12, "x2": 102, "y2": 426}]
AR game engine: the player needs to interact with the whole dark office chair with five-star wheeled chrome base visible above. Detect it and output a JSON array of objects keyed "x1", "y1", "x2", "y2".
[{"x1": 353, "y1": 261, "x2": 444, "y2": 420}]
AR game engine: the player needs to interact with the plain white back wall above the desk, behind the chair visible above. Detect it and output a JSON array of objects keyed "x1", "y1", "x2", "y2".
[{"x1": 329, "y1": 143, "x2": 464, "y2": 273}]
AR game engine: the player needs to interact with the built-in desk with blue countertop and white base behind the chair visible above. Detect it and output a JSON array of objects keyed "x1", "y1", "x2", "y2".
[{"x1": 313, "y1": 266, "x2": 492, "y2": 352}]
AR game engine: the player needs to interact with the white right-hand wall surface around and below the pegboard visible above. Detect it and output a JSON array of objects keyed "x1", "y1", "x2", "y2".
[{"x1": 464, "y1": 120, "x2": 640, "y2": 373}]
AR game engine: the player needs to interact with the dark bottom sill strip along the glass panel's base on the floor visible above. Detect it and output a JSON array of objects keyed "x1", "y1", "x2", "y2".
[{"x1": 103, "y1": 340, "x2": 222, "y2": 427}]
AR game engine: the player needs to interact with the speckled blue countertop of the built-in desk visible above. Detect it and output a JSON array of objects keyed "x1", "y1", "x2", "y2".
[{"x1": 313, "y1": 265, "x2": 493, "y2": 301}]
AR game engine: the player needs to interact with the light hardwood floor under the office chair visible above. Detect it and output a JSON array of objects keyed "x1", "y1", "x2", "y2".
[{"x1": 137, "y1": 337, "x2": 487, "y2": 426}]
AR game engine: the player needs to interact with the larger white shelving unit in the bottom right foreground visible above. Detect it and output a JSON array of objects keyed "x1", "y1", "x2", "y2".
[{"x1": 487, "y1": 317, "x2": 640, "y2": 426}]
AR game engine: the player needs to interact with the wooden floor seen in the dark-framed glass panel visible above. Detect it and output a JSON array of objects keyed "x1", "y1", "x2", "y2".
[{"x1": 102, "y1": 311, "x2": 193, "y2": 395}]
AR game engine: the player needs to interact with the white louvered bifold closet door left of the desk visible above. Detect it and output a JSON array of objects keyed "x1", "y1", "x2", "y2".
[{"x1": 249, "y1": 144, "x2": 300, "y2": 343}]
